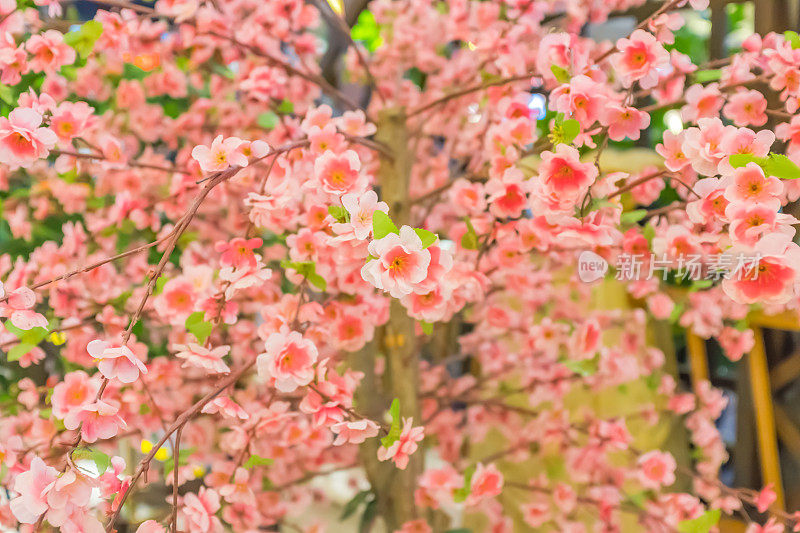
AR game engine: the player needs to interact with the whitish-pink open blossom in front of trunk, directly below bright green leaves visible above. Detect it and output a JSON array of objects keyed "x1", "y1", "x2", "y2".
[{"x1": 361, "y1": 226, "x2": 431, "y2": 298}]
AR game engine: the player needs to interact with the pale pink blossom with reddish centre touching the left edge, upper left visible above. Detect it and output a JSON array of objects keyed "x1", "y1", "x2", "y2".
[{"x1": 0, "y1": 107, "x2": 58, "y2": 167}]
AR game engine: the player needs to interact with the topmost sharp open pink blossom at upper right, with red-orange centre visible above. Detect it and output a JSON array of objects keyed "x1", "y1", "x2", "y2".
[{"x1": 612, "y1": 30, "x2": 669, "y2": 89}]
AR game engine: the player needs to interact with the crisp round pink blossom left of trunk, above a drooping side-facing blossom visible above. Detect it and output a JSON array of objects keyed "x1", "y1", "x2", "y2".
[{"x1": 257, "y1": 329, "x2": 317, "y2": 392}]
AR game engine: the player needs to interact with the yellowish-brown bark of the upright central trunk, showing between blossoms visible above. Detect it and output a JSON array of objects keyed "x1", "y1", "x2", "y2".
[{"x1": 353, "y1": 109, "x2": 423, "y2": 531}]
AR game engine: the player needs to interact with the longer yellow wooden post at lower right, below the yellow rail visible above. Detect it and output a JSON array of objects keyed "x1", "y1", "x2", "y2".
[{"x1": 747, "y1": 324, "x2": 784, "y2": 509}]
